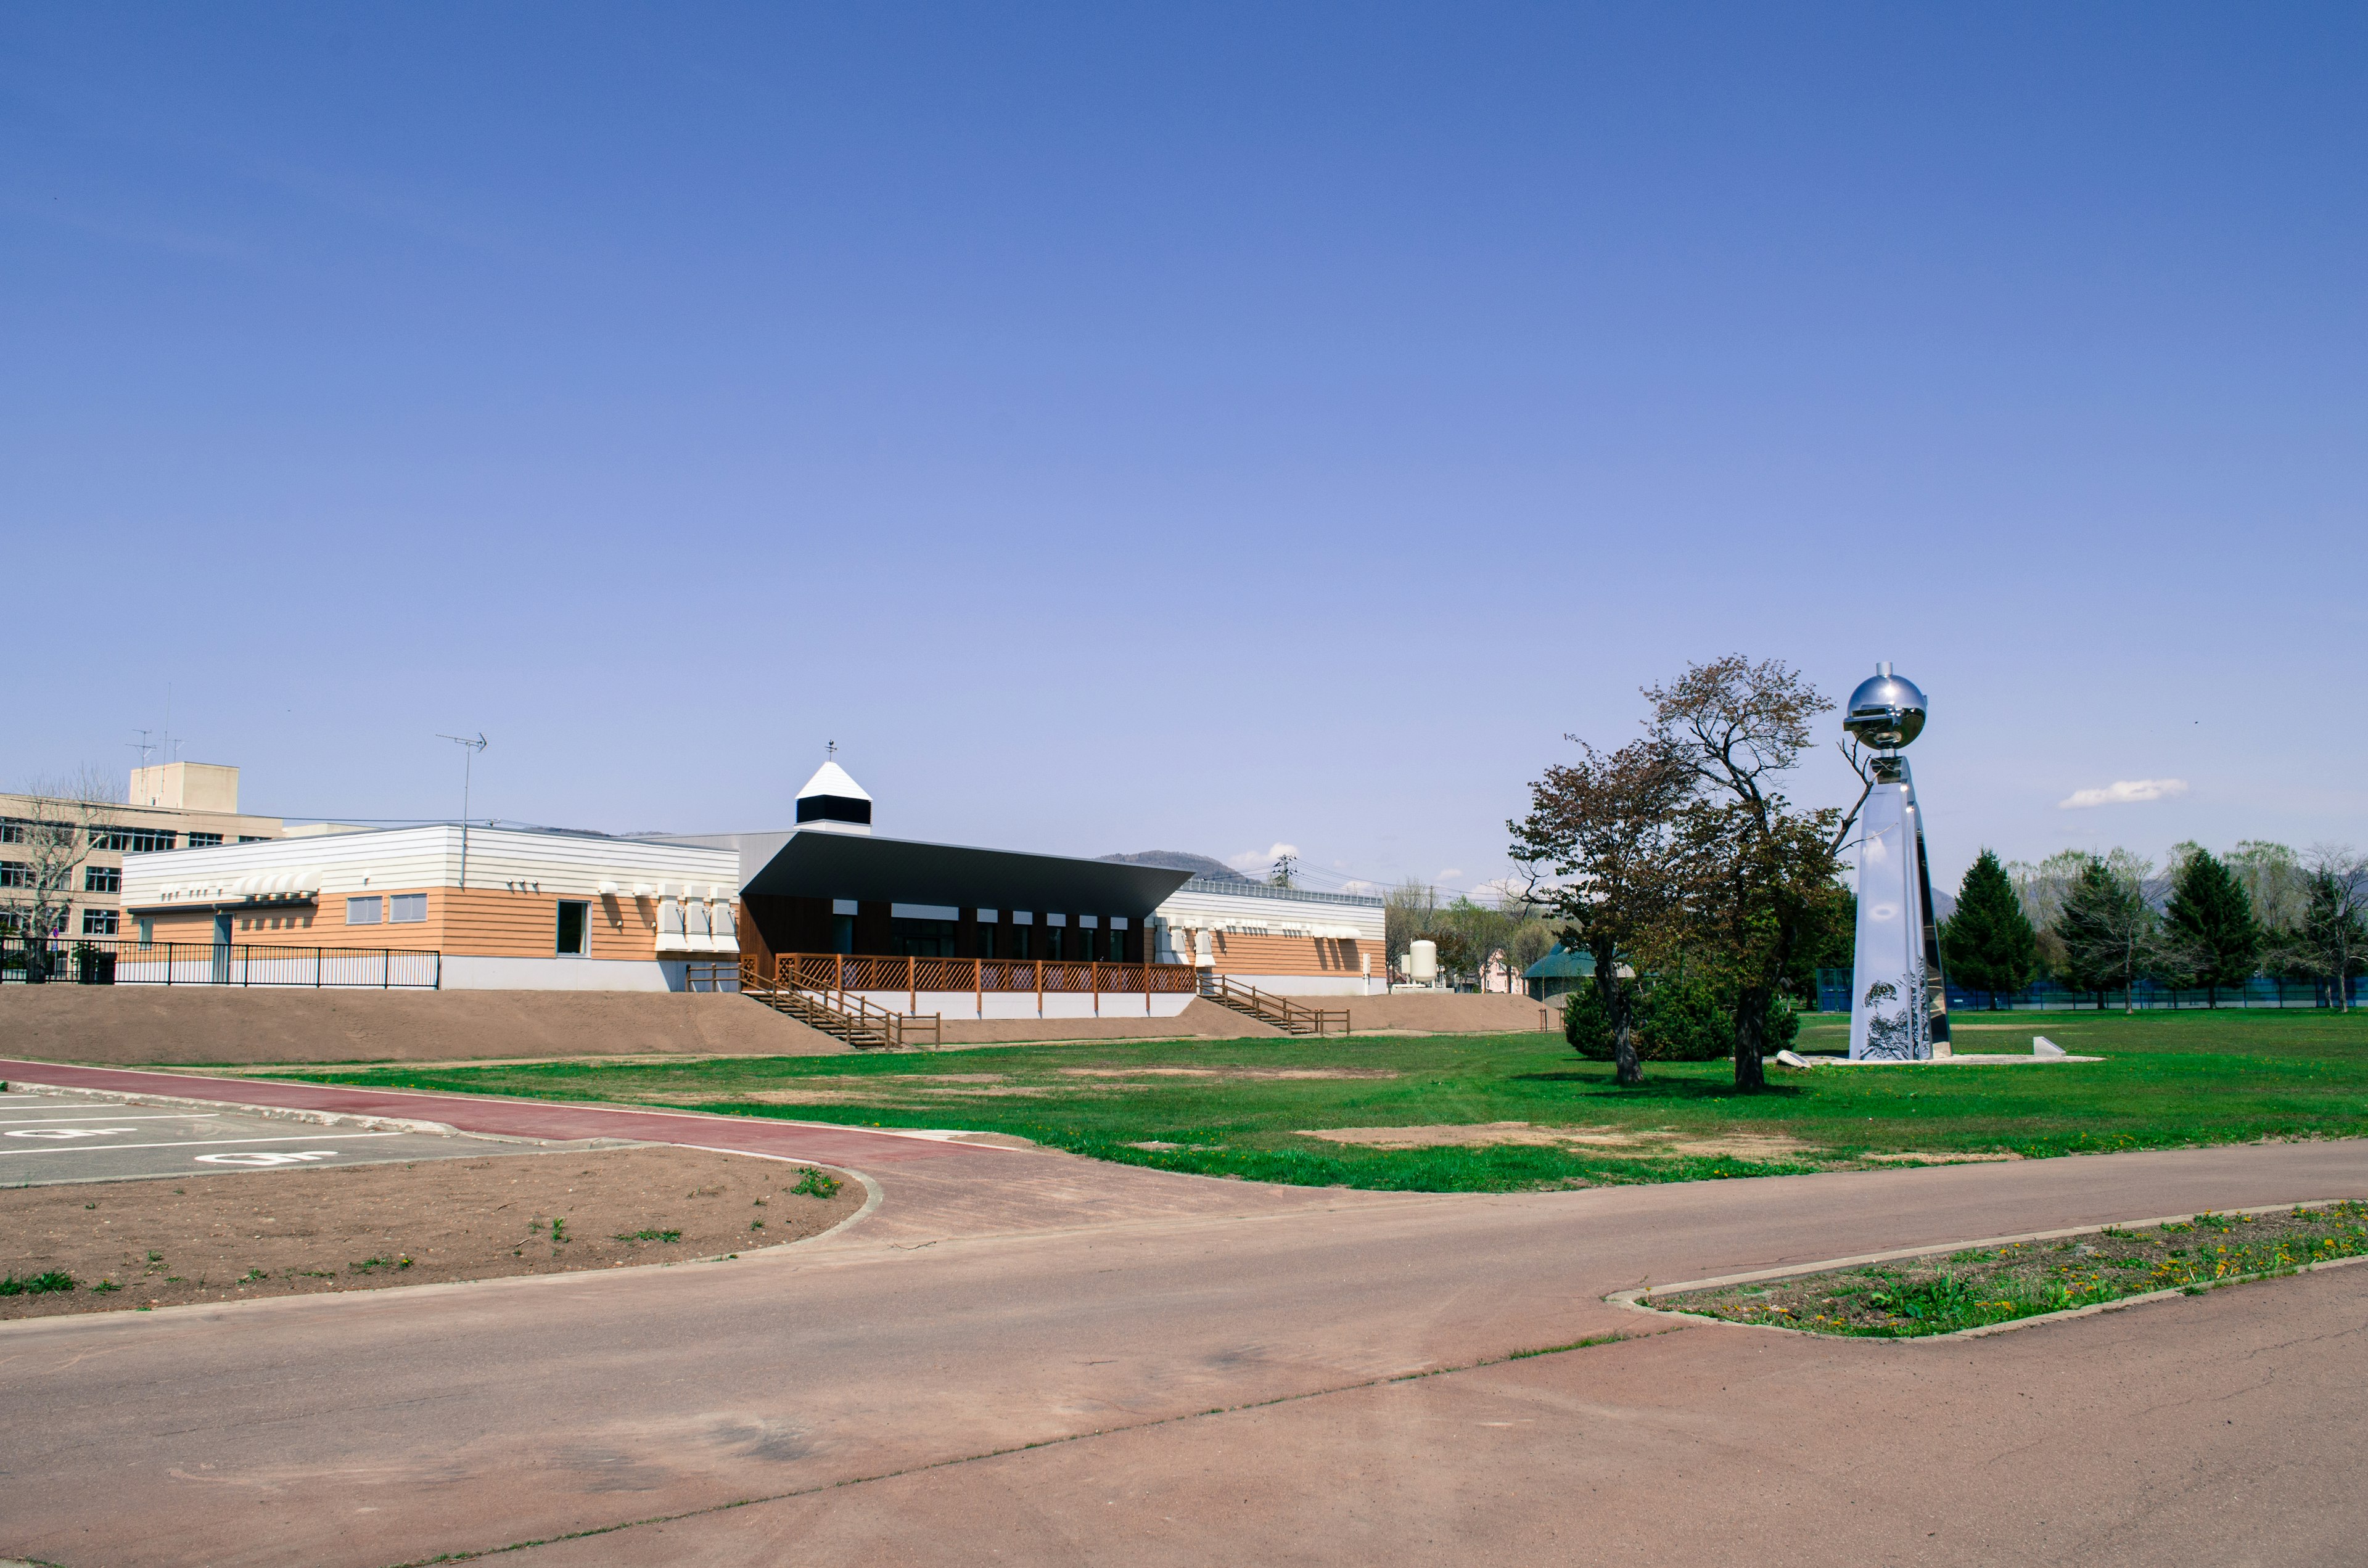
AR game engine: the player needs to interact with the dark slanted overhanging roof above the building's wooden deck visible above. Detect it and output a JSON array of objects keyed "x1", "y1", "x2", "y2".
[{"x1": 741, "y1": 831, "x2": 1191, "y2": 919}]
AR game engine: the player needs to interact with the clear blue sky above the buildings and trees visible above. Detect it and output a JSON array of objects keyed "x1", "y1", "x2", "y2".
[{"x1": 0, "y1": 5, "x2": 2368, "y2": 884}]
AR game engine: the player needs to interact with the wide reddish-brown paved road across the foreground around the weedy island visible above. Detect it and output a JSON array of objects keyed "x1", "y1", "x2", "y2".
[{"x1": 0, "y1": 1066, "x2": 2368, "y2": 1566}]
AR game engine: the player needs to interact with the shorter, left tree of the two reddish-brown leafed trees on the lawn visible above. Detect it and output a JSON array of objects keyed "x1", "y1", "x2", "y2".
[{"x1": 1506, "y1": 737, "x2": 1693, "y2": 1085}]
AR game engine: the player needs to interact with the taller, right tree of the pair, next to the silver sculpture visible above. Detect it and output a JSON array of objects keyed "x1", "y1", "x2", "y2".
[{"x1": 1646, "y1": 654, "x2": 1873, "y2": 1094}]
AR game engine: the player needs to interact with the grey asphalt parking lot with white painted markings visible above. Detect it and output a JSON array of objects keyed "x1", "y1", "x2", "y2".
[{"x1": 0, "y1": 1090, "x2": 538, "y2": 1187}]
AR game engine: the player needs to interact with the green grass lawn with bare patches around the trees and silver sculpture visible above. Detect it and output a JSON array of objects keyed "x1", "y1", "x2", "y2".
[{"x1": 274, "y1": 1011, "x2": 2368, "y2": 1191}]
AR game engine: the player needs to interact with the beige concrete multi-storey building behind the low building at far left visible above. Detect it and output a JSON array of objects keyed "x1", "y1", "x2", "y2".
[{"x1": 0, "y1": 763, "x2": 287, "y2": 938}]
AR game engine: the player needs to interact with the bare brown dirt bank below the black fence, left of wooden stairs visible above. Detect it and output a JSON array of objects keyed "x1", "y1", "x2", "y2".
[{"x1": 0, "y1": 985, "x2": 848, "y2": 1066}]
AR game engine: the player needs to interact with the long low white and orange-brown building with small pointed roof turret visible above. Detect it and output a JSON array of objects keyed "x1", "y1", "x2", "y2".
[{"x1": 118, "y1": 763, "x2": 1388, "y2": 1019}]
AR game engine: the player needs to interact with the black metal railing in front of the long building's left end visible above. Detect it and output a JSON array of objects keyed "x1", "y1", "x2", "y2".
[{"x1": 0, "y1": 935, "x2": 443, "y2": 990}]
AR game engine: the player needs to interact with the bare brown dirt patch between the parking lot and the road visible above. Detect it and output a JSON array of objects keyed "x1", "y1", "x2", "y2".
[{"x1": 0, "y1": 1146, "x2": 865, "y2": 1320}]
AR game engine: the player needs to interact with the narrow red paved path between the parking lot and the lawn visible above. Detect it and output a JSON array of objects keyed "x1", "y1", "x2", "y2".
[{"x1": 0, "y1": 1061, "x2": 978, "y2": 1165}]
